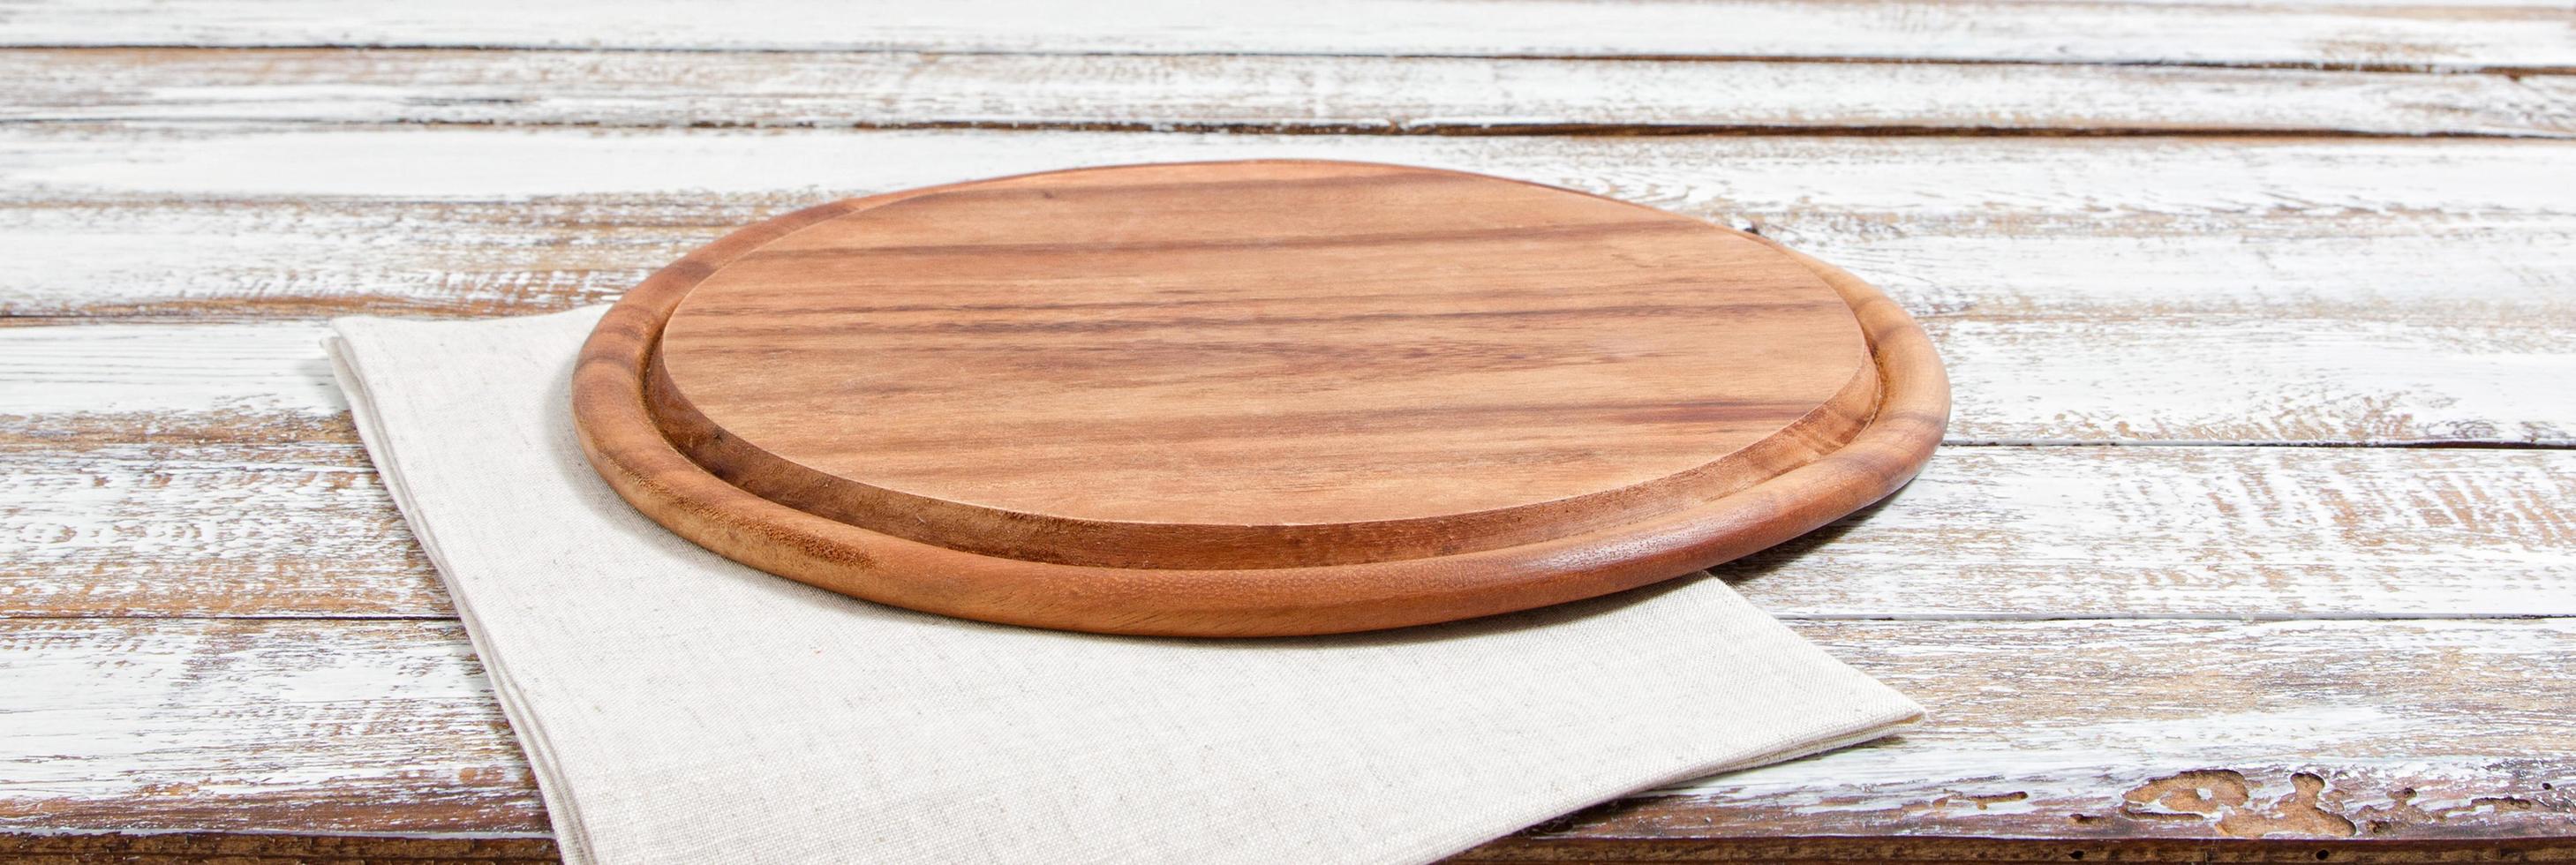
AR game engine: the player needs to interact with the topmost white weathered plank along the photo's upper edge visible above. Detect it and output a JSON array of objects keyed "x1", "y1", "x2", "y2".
[{"x1": 0, "y1": 0, "x2": 2576, "y2": 70}]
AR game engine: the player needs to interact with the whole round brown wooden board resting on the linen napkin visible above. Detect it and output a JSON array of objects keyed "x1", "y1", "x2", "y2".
[{"x1": 575, "y1": 162, "x2": 1950, "y2": 636}]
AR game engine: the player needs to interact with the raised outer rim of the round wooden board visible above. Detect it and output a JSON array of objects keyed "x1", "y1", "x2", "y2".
[{"x1": 572, "y1": 160, "x2": 1950, "y2": 636}]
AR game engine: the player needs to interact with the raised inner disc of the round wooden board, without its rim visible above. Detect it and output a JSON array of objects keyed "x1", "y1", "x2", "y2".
[{"x1": 641, "y1": 160, "x2": 1878, "y2": 567}]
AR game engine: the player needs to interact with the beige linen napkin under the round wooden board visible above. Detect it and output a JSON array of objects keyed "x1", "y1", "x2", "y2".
[{"x1": 328, "y1": 309, "x2": 1919, "y2": 862}]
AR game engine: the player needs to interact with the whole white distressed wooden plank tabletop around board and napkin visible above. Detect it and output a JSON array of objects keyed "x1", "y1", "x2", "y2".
[{"x1": 0, "y1": 0, "x2": 2576, "y2": 860}]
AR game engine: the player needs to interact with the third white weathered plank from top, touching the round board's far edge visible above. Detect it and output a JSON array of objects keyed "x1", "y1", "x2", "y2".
[{"x1": 19, "y1": 121, "x2": 2576, "y2": 212}]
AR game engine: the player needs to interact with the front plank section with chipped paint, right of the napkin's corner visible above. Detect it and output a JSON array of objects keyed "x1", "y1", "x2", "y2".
[{"x1": 1628, "y1": 621, "x2": 2576, "y2": 837}]
